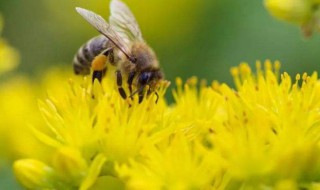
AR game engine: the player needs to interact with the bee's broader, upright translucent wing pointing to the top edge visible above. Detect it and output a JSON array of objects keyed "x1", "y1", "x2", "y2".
[{"x1": 109, "y1": 0, "x2": 143, "y2": 43}]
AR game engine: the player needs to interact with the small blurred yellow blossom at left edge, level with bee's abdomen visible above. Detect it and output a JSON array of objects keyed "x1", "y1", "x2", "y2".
[{"x1": 0, "y1": 15, "x2": 19, "y2": 75}]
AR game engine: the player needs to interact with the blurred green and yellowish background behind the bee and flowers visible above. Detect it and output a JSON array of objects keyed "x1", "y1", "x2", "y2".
[{"x1": 0, "y1": 0, "x2": 320, "y2": 189}]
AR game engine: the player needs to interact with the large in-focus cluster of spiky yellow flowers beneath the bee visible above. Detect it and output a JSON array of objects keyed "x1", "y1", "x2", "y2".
[{"x1": 14, "y1": 61, "x2": 320, "y2": 190}]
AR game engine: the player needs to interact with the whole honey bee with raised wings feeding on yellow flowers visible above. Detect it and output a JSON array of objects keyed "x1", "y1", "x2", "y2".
[{"x1": 73, "y1": 0, "x2": 164, "y2": 103}]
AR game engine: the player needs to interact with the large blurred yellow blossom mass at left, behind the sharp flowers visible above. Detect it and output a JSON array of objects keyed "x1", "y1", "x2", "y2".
[{"x1": 0, "y1": 69, "x2": 78, "y2": 161}]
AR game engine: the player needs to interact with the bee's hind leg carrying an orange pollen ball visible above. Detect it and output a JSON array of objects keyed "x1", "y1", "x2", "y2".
[{"x1": 91, "y1": 54, "x2": 108, "y2": 83}]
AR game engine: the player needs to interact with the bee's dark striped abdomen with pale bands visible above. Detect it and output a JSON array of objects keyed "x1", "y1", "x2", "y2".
[{"x1": 73, "y1": 35, "x2": 112, "y2": 75}]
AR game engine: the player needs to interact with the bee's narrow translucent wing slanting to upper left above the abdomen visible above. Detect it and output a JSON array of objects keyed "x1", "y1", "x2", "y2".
[{"x1": 76, "y1": 7, "x2": 133, "y2": 60}]
